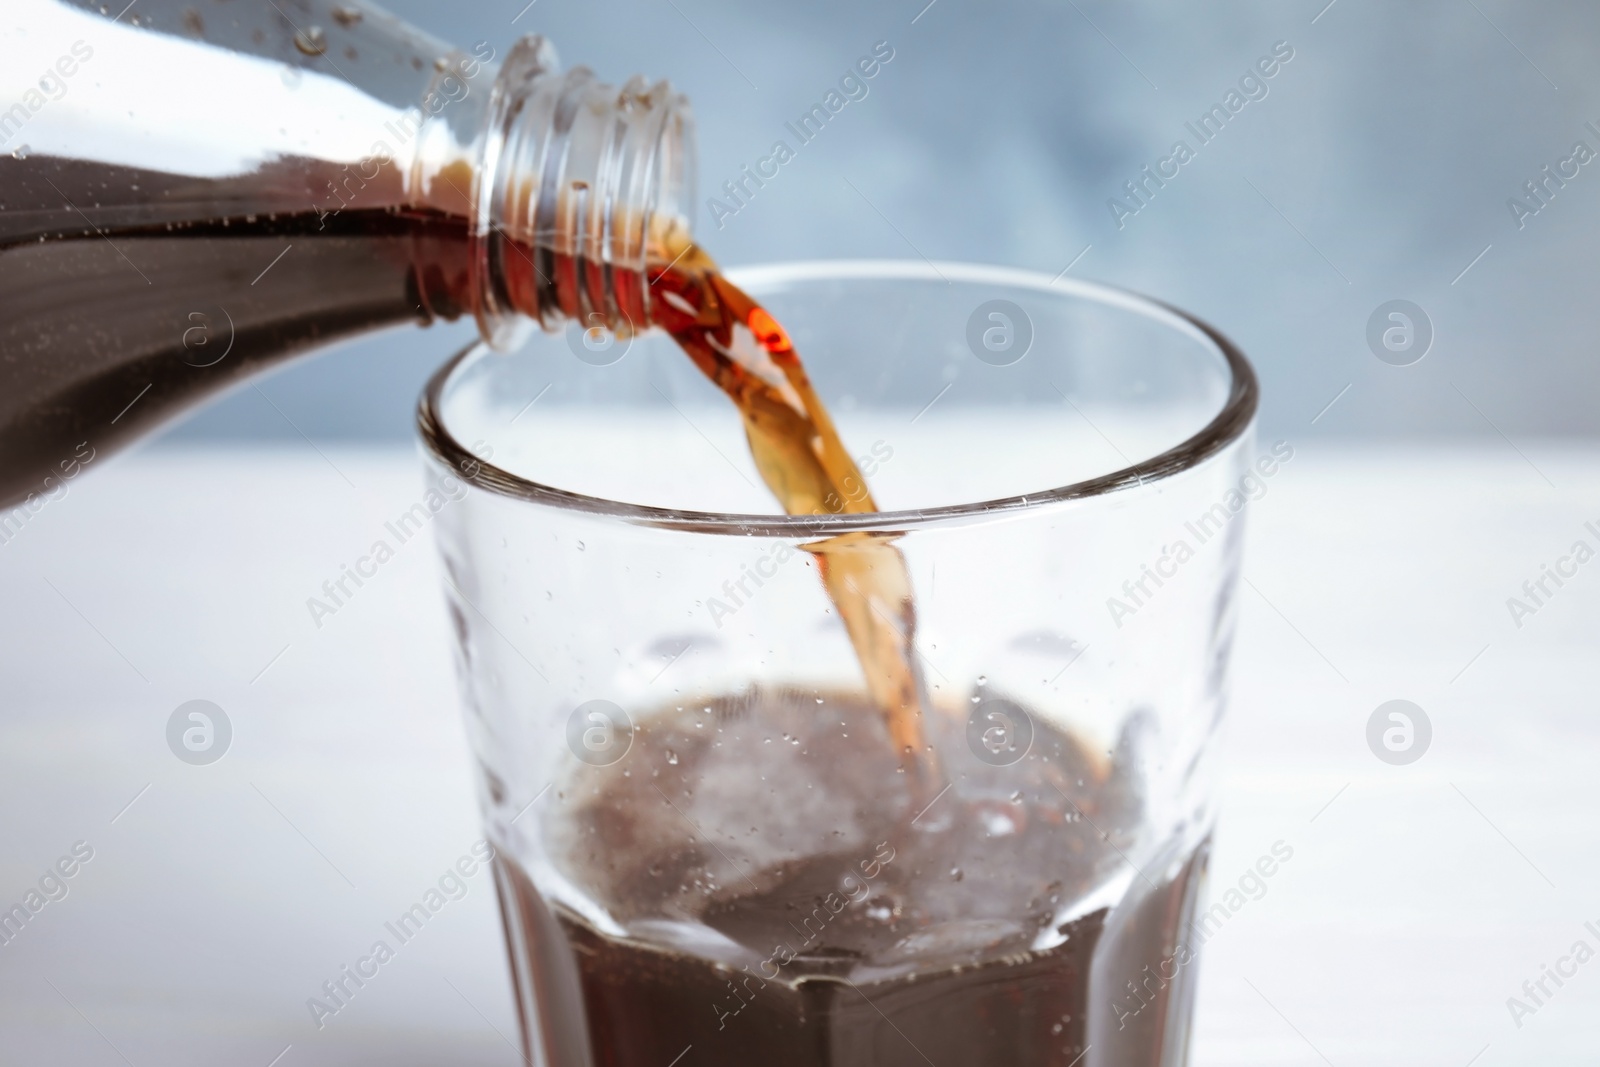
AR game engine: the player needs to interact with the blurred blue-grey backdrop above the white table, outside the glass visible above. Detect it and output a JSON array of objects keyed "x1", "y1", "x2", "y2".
[{"x1": 173, "y1": 0, "x2": 1600, "y2": 440}]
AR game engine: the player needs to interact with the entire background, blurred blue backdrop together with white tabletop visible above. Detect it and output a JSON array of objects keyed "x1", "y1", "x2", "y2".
[{"x1": 0, "y1": 0, "x2": 1600, "y2": 1067}]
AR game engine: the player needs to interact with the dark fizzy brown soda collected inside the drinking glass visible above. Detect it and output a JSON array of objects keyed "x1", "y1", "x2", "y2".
[{"x1": 498, "y1": 689, "x2": 1205, "y2": 1067}]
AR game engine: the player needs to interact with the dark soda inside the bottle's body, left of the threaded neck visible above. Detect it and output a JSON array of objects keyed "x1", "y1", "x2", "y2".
[{"x1": 0, "y1": 157, "x2": 470, "y2": 507}]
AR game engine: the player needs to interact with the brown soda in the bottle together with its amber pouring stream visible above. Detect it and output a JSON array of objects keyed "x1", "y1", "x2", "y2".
[{"x1": 0, "y1": 157, "x2": 936, "y2": 771}]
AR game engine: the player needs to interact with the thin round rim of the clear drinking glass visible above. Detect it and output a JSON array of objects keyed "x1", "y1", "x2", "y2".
[{"x1": 416, "y1": 259, "x2": 1259, "y2": 537}]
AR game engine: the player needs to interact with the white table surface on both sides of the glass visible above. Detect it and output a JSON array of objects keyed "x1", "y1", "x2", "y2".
[{"x1": 0, "y1": 442, "x2": 1600, "y2": 1067}]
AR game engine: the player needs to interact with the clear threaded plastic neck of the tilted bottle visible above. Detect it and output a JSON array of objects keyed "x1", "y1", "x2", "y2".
[{"x1": 475, "y1": 37, "x2": 694, "y2": 349}]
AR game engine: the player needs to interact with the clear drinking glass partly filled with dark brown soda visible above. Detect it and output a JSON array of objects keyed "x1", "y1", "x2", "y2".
[{"x1": 419, "y1": 262, "x2": 1254, "y2": 1067}]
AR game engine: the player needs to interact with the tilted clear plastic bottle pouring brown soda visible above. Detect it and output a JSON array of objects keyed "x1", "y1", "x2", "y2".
[{"x1": 0, "y1": 0, "x2": 693, "y2": 507}]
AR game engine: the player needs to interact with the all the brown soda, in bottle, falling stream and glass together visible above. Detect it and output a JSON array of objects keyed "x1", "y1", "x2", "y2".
[{"x1": 0, "y1": 158, "x2": 1205, "y2": 1067}]
